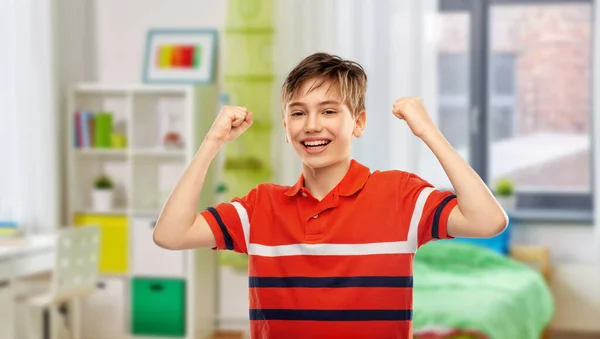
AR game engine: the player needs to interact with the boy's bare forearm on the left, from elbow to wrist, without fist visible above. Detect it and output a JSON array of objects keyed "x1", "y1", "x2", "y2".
[{"x1": 154, "y1": 140, "x2": 221, "y2": 244}]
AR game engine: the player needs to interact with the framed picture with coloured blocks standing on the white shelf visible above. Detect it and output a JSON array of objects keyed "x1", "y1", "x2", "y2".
[{"x1": 142, "y1": 28, "x2": 218, "y2": 84}]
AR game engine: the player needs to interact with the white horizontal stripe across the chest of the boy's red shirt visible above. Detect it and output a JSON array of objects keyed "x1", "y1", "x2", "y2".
[{"x1": 248, "y1": 241, "x2": 414, "y2": 257}]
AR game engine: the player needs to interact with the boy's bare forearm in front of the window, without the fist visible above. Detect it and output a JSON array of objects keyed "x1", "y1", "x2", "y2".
[{"x1": 422, "y1": 129, "x2": 507, "y2": 233}]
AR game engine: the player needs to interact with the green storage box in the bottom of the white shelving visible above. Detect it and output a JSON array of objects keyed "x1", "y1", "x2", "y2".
[{"x1": 131, "y1": 278, "x2": 186, "y2": 337}]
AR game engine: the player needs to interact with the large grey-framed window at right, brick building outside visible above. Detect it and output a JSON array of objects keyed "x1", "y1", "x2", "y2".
[{"x1": 438, "y1": 0, "x2": 593, "y2": 220}]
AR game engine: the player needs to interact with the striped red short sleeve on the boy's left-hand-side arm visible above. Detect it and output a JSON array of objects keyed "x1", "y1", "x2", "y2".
[{"x1": 200, "y1": 188, "x2": 257, "y2": 254}]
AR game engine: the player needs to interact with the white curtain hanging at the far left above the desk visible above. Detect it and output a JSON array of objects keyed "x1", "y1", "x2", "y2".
[{"x1": 0, "y1": 0, "x2": 60, "y2": 233}]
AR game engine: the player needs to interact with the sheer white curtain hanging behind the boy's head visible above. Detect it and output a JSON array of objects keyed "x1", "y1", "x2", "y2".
[{"x1": 274, "y1": 0, "x2": 437, "y2": 184}]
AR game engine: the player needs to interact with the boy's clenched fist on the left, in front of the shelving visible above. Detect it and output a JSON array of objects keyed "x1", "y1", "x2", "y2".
[{"x1": 206, "y1": 106, "x2": 252, "y2": 144}]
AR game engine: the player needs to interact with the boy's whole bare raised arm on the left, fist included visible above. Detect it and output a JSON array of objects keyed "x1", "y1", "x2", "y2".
[{"x1": 153, "y1": 106, "x2": 252, "y2": 250}]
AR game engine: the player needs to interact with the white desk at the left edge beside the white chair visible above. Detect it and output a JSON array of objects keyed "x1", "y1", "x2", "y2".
[{"x1": 0, "y1": 234, "x2": 56, "y2": 339}]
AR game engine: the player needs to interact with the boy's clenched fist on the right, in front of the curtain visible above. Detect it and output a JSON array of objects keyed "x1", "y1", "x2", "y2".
[{"x1": 392, "y1": 97, "x2": 437, "y2": 138}]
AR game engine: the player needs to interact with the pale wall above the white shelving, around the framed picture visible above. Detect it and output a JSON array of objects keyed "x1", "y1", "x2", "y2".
[{"x1": 94, "y1": 0, "x2": 227, "y2": 83}]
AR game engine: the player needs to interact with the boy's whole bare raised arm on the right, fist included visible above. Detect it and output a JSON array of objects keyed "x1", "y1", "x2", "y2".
[{"x1": 393, "y1": 98, "x2": 508, "y2": 238}]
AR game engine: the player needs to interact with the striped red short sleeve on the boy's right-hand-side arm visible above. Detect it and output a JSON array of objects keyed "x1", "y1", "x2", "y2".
[{"x1": 399, "y1": 173, "x2": 458, "y2": 248}]
